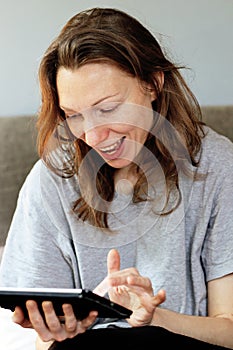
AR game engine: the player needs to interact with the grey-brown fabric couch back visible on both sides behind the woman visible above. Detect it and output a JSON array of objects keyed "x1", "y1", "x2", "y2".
[{"x1": 0, "y1": 105, "x2": 233, "y2": 259}]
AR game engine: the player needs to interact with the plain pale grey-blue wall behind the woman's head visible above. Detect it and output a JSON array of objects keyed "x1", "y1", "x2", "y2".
[{"x1": 0, "y1": 0, "x2": 233, "y2": 116}]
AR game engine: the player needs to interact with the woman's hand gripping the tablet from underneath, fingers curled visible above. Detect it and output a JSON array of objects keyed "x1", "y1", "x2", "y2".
[{"x1": 13, "y1": 300, "x2": 98, "y2": 342}]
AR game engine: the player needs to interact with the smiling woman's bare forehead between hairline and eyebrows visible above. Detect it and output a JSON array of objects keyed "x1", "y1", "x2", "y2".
[{"x1": 57, "y1": 63, "x2": 137, "y2": 110}]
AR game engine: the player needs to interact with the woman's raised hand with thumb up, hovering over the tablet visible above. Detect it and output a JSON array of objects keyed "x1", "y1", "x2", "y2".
[{"x1": 94, "y1": 249, "x2": 166, "y2": 327}]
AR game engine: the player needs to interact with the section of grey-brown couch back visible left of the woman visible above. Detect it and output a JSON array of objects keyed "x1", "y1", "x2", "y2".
[{"x1": 0, "y1": 116, "x2": 38, "y2": 246}]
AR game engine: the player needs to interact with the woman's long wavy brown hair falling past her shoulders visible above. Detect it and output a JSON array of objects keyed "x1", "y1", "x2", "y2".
[{"x1": 37, "y1": 8, "x2": 203, "y2": 228}]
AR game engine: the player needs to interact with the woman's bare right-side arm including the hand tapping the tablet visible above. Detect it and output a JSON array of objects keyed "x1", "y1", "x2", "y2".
[{"x1": 104, "y1": 250, "x2": 233, "y2": 349}]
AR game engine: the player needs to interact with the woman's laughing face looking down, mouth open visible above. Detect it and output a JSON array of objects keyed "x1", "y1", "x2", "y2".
[{"x1": 57, "y1": 63, "x2": 155, "y2": 169}]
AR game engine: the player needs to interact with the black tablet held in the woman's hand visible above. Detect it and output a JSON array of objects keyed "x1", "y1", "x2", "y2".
[{"x1": 0, "y1": 287, "x2": 132, "y2": 320}]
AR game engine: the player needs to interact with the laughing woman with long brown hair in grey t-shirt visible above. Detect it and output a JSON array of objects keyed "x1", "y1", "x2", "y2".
[{"x1": 1, "y1": 8, "x2": 233, "y2": 349}]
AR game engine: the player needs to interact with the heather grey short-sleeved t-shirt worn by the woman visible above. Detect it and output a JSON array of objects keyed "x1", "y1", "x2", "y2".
[{"x1": 0, "y1": 129, "x2": 233, "y2": 316}]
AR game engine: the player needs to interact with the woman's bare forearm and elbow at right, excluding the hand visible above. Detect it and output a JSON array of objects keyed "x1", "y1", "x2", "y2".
[{"x1": 144, "y1": 274, "x2": 233, "y2": 349}]
